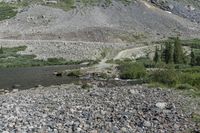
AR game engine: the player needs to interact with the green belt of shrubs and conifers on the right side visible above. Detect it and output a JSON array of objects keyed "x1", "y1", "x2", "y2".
[{"x1": 115, "y1": 38, "x2": 200, "y2": 97}]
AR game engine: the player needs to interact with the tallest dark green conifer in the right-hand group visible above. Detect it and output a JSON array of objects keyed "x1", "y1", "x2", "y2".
[{"x1": 174, "y1": 37, "x2": 183, "y2": 64}]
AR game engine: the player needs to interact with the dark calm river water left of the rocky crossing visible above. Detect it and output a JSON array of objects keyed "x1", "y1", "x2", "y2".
[{"x1": 0, "y1": 65, "x2": 80, "y2": 89}]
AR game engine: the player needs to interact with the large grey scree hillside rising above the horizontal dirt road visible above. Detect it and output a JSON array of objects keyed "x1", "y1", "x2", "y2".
[{"x1": 0, "y1": 0, "x2": 200, "y2": 42}]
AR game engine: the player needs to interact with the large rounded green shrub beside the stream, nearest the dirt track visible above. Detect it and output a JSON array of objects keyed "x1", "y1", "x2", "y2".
[{"x1": 119, "y1": 62, "x2": 146, "y2": 79}]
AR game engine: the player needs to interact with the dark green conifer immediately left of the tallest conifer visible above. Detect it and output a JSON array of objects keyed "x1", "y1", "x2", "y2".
[{"x1": 165, "y1": 43, "x2": 174, "y2": 64}]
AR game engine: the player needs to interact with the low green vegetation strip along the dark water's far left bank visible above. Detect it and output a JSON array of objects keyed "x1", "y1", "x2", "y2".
[{"x1": 0, "y1": 46, "x2": 96, "y2": 68}]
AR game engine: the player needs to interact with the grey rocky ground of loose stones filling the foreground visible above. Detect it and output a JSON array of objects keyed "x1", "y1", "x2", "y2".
[{"x1": 0, "y1": 85, "x2": 199, "y2": 133}]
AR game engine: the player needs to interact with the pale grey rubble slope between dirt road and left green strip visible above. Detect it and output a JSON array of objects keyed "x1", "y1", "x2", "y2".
[{"x1": 0, "y1": 40, "x2": 128, "y2": 61}]
